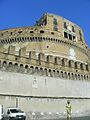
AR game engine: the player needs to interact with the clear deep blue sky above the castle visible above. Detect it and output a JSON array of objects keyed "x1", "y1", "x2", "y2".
[{"x1": 0, "y1": 0, "x2": 90, "y2": 48}]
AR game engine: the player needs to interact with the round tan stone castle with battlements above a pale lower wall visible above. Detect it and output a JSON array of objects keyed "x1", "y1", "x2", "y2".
[{"x1": 0, "y1": 13, "x2": 90, "y2": 117}]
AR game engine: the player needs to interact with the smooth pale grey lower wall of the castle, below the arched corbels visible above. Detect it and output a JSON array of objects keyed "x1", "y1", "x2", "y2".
[{"x1": 0, "y1": 71, "x2": 90, "y2": 113}]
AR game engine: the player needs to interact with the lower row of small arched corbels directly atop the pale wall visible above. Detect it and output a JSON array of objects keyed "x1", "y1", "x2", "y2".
[{"x1": 0, "y1": 58, "x2": 90, "y2": 80}]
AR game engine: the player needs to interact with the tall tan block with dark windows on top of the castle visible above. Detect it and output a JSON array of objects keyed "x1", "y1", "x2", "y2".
[{"x1": 36, "y1": 13, "x2": 85, "y2": 43}]
